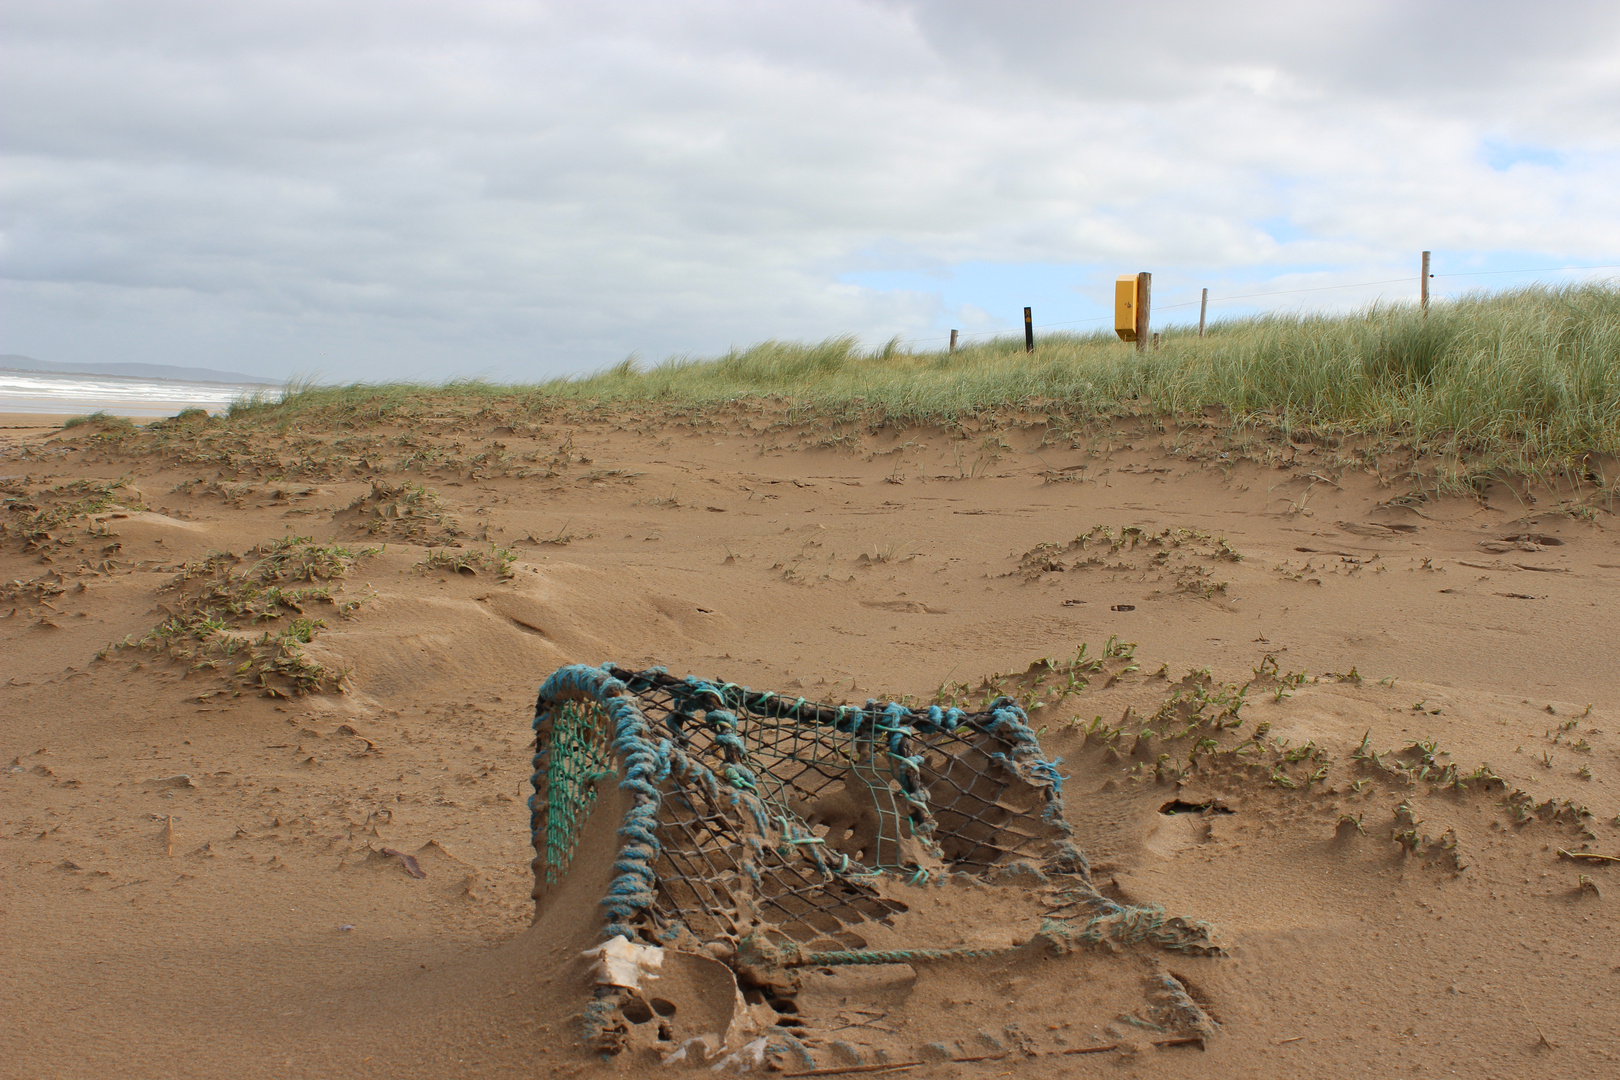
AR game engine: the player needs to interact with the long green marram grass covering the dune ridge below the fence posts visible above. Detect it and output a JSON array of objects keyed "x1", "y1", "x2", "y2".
[{"x1": 232, "y1": 282, "x2": 1620, "y2": 471}]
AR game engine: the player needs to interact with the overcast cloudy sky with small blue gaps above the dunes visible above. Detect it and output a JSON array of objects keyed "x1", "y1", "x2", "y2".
[{"x1": 0, "y1": 0, "x2": 1620, "y2": 379}]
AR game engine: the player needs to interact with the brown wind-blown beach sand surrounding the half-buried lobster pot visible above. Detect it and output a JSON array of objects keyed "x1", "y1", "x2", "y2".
[{"x1": 0, "y1": 408, "x2": 1620, "y2": 1077}]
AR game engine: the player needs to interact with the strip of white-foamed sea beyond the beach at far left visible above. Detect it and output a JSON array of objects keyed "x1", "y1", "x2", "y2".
[{"x1": 0, "y1": 371, "x2": 280, "y2": 418}]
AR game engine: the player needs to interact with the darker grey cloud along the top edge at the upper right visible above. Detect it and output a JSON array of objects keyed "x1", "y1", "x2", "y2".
[{"x1": 893, "y1": 0, "x2": 1620, "y2": 102}]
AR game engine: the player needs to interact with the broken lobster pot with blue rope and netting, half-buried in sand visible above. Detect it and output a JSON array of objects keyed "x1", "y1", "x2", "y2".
[{"x1": 530, "y1": 664, "x2": 1218, "y2": 1069}]
